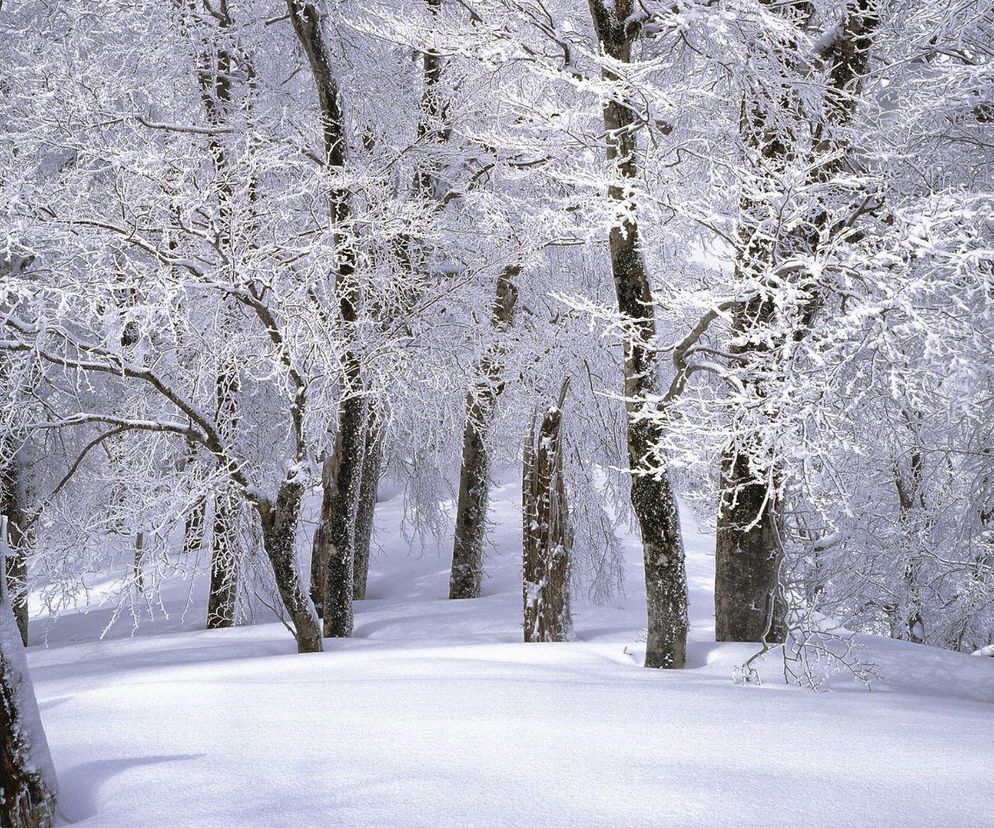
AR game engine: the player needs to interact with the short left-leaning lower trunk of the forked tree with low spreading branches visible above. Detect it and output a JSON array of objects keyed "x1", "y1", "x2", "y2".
[{"x1": 258, "y1": 478, "x2": 322, "y2": 653}]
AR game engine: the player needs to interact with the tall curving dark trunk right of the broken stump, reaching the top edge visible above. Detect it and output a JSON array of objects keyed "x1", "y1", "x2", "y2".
[{"x1": 590, "y1": 0, "x2": 687, "y2": 668}]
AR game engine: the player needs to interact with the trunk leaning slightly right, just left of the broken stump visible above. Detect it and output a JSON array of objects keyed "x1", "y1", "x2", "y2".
[{"x1": 449, "y1": 266, "x2": 521, "y2": 598}]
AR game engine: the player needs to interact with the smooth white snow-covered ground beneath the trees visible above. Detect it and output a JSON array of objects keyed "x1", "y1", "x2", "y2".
[{"x1": 23, "y1": 484, "x2": 994, "y2": 828}]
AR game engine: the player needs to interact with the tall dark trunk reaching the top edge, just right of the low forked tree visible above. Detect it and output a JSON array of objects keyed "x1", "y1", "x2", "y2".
[{"x1": 287, "y1": 0, "x2": 366, "y2": 637}]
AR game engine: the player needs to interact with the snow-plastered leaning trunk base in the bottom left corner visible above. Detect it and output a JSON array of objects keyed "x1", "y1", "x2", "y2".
[{"x1": 0, "y1": 521, "x2": 57, "y2": 828}]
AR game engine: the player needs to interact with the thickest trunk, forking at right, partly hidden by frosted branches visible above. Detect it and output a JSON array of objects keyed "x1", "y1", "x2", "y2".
[{"x1": 715, "y1": 0, "x2": 880, "y2": 643}]
